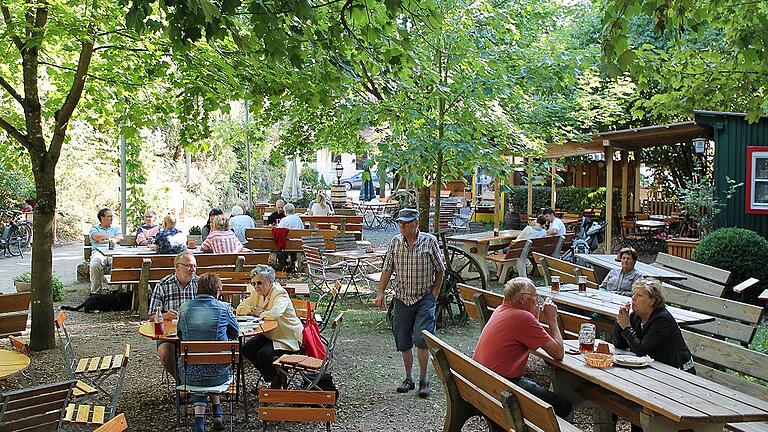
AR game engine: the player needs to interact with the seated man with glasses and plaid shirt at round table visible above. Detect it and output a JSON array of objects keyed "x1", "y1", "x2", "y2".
[{"x1": 149, "y1": 251, "x2": 197, "y2": 377}]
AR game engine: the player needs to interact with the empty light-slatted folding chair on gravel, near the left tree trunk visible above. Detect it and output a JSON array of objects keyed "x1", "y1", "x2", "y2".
[{"x1": 54, "y1": 311, "x2": 131, "y2": 423}]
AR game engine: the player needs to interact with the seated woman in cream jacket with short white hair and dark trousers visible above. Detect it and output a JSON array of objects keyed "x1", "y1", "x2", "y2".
[{"x1": 237, "y1": 264, "x2": 304, "y2": 388}]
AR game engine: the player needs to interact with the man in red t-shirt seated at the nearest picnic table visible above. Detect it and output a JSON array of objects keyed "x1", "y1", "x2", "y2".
[{"x1": 472, "y1": 277, "x2": 573, "y2": 417}]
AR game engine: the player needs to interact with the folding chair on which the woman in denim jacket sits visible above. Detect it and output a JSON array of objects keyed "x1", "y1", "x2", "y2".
[{"x1": 175, "y1": 340, "x2": 248, "y2": 431}]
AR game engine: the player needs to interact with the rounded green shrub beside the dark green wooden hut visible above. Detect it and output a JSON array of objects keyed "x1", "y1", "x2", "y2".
[{"x1": 692, "y1": 228, "x2": 768, "y2": 304}]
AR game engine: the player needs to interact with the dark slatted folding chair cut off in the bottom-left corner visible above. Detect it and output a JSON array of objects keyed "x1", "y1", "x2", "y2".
[{"x1": 0, "y1": 380, "x2": 75, "y2": 432}]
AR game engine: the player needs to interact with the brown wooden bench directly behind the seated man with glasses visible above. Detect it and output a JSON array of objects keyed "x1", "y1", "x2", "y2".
[{"x1": 107, "y1": 252, "x2": 269, "y2": 316}]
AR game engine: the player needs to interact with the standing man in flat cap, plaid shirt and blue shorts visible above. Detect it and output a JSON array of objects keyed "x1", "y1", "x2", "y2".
[{"x1": 376, "y1": 209, "x2": 445, "y2": 398}]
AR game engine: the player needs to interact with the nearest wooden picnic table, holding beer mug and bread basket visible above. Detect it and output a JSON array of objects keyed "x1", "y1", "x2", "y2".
[{"x1": 534, "y1": 340, "x2": 768, "y2": 432}]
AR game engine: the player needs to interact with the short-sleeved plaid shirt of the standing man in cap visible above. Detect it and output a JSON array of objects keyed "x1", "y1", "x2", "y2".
[{"x1": 381, "y1": 232, "x2": 445, "y2": 306}]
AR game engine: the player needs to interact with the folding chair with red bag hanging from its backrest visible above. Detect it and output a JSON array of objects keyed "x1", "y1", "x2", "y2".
[{"x1": 274, "y1": 312, "x2": 344, "y2": 390}]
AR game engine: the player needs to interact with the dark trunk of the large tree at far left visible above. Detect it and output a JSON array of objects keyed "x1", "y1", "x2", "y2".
[{"x1": 29, "y1": 148, "x2": 56, "y2": 351}]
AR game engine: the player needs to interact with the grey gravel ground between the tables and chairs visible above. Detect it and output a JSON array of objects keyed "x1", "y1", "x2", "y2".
[{"x1": 0, "y1": 228, "x2": 628, "y2": 431}]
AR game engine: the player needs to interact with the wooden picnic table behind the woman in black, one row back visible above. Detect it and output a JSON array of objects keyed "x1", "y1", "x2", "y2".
[{"x1": 536, "y1": 284, "x2": 715, "y2": 327}]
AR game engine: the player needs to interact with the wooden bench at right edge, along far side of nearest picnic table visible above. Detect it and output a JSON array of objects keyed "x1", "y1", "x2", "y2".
[{"x1": 682, "y1": 330, "x2": 768, "y2": 432}]
